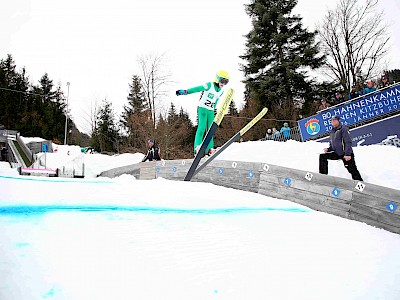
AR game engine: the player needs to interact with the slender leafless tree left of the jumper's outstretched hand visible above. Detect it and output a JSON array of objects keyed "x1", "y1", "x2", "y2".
[{"x1": 138, "y1": 54, "x2": 171, "y2": 129}]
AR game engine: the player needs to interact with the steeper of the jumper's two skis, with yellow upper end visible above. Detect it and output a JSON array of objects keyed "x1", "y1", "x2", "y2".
[{"x1": 184, "y1": 89, "x2": 235, "y2": 181}]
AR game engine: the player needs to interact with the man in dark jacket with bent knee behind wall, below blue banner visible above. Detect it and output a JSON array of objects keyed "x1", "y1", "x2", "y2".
[{"x1": 319, "y1": 116, "x2": 363, "y2": 181}]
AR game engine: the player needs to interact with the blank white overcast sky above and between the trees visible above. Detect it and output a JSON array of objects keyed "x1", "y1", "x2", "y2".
[{"x1": 0, "y1": 0, "x2": 400, "y2": 132}]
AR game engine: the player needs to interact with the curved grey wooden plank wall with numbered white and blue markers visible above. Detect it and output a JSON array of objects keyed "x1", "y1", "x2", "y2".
[{"x1": 97, "y1": 159, "x2": 400, "y2": 234}]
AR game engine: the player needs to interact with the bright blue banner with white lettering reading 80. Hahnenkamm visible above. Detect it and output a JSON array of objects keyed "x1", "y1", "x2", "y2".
[{"x1": 298, "y1": 85, "x2": 400, "y2": 141}]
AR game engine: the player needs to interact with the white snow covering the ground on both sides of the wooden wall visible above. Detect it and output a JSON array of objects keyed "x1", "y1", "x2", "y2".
[{"x1": 0, "y1": 141, "x2": 400, "y2": 300}]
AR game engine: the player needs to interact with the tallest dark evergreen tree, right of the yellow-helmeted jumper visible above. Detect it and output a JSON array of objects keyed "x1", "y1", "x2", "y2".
[{"x1": 241, "y1": 0, "x2": 324, "y2": 119}]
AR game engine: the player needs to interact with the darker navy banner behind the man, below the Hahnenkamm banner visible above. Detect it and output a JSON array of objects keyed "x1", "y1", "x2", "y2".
[{"x1": 318, "y1": 115, "x2": 400, "y2": 148}]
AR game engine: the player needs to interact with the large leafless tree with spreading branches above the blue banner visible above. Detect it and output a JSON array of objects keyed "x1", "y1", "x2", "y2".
[{"x1": 318, "y1": 0, "x2": 390, "y2": 91}]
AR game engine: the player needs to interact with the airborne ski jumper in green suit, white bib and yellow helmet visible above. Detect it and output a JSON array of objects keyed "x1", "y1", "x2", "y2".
[{"x1": 176, "y1": 71, "x2": 229, "y2": 154}]
